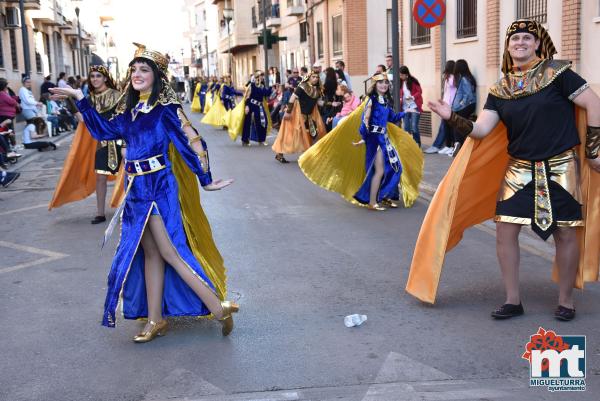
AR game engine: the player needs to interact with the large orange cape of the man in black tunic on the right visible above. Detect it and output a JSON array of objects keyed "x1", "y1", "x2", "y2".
[{"x1": 406, "y1": 108, "x2": 600, "y2": 303}]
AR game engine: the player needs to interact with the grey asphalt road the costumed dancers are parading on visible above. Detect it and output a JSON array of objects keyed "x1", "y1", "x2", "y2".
[{"x1": 0, "y1": 104, "x2": 600, "y2": 401}]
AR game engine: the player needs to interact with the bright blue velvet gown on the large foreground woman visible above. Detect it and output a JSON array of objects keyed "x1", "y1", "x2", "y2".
[{"x1": 77, "y1": 99, "x2": 215, "y2": 327}]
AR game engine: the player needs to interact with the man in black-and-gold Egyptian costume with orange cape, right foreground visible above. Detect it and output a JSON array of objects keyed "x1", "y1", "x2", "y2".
[{"x1": 406, "y1": 20, "x2": 600, "y2": 321}]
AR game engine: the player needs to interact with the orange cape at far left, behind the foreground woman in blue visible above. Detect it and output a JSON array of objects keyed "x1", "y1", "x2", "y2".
[{"x1": 48, "y1": 122, "x2": 123, "y2": 210}]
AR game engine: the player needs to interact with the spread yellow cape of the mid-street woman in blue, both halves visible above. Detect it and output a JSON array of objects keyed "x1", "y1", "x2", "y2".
[{"x1": 298, "y1": 102, "x2": 424, "y2": 207}]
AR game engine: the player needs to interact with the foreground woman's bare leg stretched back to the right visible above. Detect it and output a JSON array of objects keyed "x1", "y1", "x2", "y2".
[{"x1": 148, "y1": 216, "x2": 223, "y2": 319}]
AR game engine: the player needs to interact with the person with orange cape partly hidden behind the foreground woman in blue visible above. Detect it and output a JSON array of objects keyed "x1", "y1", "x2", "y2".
[{"x1": 48, "y1": 65, "x2": 124, "y2": 224}]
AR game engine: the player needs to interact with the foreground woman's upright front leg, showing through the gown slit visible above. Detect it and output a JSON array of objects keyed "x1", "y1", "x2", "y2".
[{"x1": 142, "y1": 227, "x2": 165, "y2": 331}]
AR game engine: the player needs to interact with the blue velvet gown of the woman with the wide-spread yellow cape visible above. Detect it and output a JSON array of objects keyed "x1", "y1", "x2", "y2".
[{"x1": 354, "y1": 96, "x2": 404, "y2": 204}]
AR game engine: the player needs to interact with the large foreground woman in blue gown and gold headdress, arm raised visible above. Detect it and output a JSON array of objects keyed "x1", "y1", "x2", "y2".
[{"x1": 53, "y1": 44, "x2": 238, "y2": 342}]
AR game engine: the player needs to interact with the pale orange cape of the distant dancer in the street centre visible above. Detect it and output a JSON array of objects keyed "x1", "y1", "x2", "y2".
[{"x1": 271, "y1": 100, "x2": 327, "y2": 154}]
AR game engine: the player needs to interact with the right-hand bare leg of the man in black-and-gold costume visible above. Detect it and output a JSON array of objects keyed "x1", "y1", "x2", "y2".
[{"x1": 553, "y1": 227, "x2": 579, "y2": 309}]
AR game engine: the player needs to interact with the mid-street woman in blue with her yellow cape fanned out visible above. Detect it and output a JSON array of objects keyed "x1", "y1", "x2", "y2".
[{"x1": 298, "y1": 73, "x2": 423, "y2": 211}]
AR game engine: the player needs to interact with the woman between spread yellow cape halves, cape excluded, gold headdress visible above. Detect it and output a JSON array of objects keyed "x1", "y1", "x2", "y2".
[{"x1": 353, "y1": 73, "x2": 404, "y2": 211}]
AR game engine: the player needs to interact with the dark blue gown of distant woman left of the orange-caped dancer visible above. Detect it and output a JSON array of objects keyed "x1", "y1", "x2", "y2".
[{"x1": 242, "y1": 82, "x2": 271, "y2": 143}]
